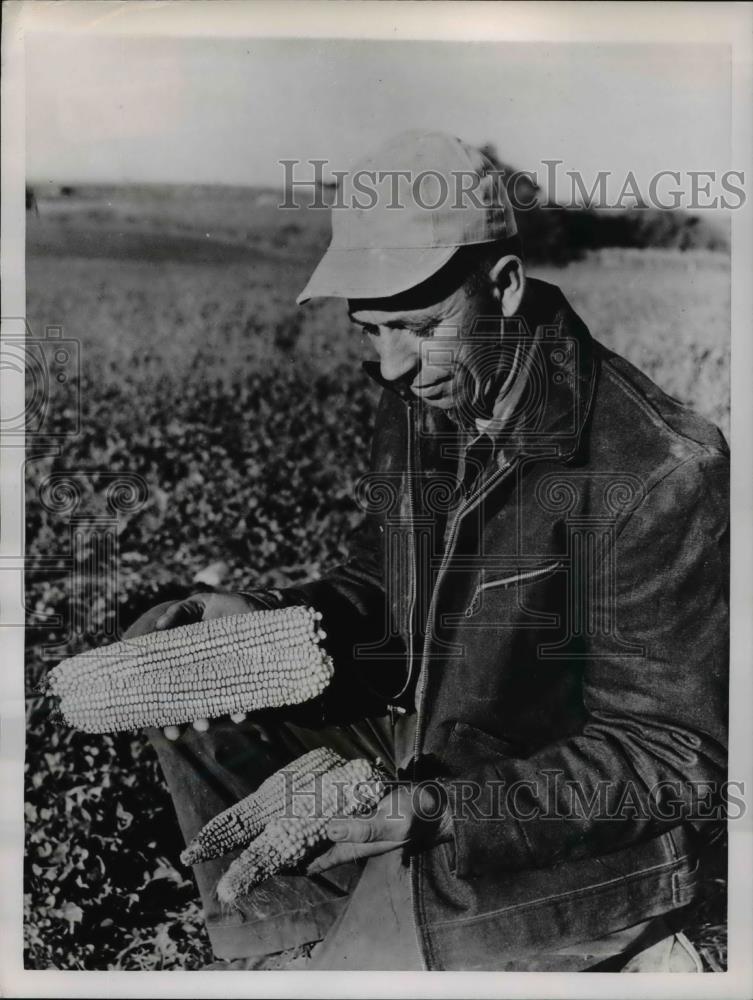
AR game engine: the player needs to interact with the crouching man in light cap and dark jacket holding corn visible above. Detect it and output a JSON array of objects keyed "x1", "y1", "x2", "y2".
[{"x1": 126, "y1": 133, "x2": 728, "y2": 971}]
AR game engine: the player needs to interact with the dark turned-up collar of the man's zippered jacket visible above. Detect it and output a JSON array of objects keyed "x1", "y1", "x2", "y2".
[{"x1": 363, "y1": 278, "x2": 597, "y2": 462}]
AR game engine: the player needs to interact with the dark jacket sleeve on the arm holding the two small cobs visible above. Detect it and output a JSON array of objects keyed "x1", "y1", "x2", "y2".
[{"x1": 446, "y1": 453, "x2": 729, "y2": 877}]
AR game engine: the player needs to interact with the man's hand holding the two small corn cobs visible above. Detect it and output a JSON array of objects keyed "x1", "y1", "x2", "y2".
[{"x1": 306, "y1": 783, "x2": 452, "y2": 875}]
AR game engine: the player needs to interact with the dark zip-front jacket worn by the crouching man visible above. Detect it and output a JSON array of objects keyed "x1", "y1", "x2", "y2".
[{"x1": 280, "y1": 281, "x2": 729, "y2": 969}]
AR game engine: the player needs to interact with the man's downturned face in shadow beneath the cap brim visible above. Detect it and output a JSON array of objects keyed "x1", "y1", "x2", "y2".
[{"x1": 348, "y1": 274, "x2": 501, "y2": 410}]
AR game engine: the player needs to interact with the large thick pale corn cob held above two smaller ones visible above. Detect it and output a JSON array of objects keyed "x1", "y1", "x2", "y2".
[{"x1": 46, "y1": 607, "x2": 334, "y2": 733}]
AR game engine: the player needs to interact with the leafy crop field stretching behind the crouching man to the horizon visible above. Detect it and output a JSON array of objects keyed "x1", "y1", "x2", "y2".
[{"x1": 25, "y1": 189, "x2": 730, "y2": 969}]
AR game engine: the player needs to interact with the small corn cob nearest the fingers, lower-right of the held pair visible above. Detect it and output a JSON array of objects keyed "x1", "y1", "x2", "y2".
[{"x1": 217, "y1": 759, "x2": 386, "y2": 905}]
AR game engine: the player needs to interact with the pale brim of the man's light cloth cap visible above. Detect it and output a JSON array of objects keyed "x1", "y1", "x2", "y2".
[{"x1": 296, "y1": 246, "x2": 458, "y2": 305}]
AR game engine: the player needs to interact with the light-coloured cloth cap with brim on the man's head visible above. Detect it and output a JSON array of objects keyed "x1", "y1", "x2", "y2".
[{"x1": 296, "y1": 131, "x2": 517, "y2": 303}]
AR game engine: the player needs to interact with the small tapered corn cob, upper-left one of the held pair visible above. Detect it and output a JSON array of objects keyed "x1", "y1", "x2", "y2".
[{"x1": 180, "y1": 747, "x2": 346, "y2": 865}]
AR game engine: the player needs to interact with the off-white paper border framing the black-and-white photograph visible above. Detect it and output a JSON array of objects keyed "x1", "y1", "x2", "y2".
[{"x1": 0, "y1": 0, "x2": 753, "y2": 1000}]
